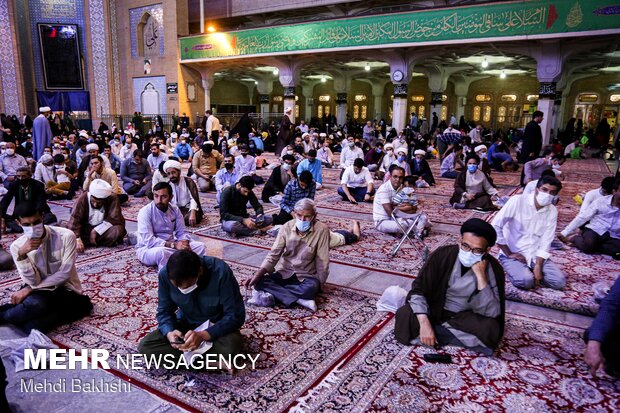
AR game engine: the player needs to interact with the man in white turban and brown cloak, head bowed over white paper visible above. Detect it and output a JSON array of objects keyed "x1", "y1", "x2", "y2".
[{"x1": 67, "y1": 179, "x2": 127, "y2": 253}]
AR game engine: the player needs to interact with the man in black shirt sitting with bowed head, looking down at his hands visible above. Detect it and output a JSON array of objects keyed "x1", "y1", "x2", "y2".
[{"x1": 220, "y1": 176, "x2": 272, "y2": 236}]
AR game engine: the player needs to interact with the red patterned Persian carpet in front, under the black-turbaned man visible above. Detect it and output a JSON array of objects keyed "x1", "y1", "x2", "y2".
[{"x1": 296, "y1": 315, "x2": 620, "y2": 413}]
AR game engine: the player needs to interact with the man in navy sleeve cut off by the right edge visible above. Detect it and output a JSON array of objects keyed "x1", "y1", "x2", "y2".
[{"x1": 584, "y1": 277, "x2": 620, "y2": 377}]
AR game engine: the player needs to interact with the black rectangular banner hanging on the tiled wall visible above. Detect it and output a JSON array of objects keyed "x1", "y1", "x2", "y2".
[{"x1": 38, "y1": 23, "x2": 84, "y2": 89}]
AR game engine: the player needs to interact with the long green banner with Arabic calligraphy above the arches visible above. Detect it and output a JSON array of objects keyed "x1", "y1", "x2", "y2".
[{"x1": 179, "y1": 0, "x2": 620, "y2": 61}]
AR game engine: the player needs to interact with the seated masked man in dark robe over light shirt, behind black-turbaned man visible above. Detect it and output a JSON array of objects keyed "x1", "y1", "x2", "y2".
[{"x1": 450, "y1": 153, "x2": 499, "y2": 211}]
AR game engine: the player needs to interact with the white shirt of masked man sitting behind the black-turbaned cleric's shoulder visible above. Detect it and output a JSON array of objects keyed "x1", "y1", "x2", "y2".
[{"x1": 491, "y1": 195, "x2": 558, "y2": 264}]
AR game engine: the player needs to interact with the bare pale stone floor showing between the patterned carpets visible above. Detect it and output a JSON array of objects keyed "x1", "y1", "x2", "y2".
[{"x1": 0, "y1": 155, "x2": 617, "y2": 413}]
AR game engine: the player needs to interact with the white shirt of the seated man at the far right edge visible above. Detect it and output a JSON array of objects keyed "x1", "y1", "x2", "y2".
[{"x1": 561, "y1": 195, "x2": 620, "y2": 239}]
